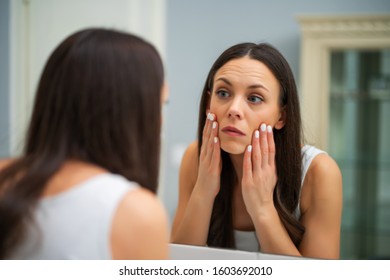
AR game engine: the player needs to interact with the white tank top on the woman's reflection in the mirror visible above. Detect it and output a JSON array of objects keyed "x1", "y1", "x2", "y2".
[{"x1": 233, "y1": 145, "x2": 326, "y2": 252}]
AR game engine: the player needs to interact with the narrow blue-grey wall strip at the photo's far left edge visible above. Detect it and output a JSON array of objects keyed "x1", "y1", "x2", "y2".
[{"x1": 0, "y1": 0, "x2": 10, "y2": 158}]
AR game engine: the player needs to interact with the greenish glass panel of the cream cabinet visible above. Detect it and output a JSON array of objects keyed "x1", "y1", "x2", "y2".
[{"x1": 328, "y1": 49, "x2": 390, "y2": 259}]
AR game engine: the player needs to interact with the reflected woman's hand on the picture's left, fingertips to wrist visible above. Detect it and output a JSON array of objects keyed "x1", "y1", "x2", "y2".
[{"x1": 194, "y1": 113, "x2": 222, "y2": 199}]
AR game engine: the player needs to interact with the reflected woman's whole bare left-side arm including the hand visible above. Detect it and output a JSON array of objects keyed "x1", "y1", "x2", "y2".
[{"x1": 172, "y1": 114, "x2": 222, "y2": 246}]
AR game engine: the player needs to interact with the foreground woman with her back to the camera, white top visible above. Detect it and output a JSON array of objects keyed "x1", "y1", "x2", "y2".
[{"x1": 0, "y1": 29, "x2": 169, "y2": 259}]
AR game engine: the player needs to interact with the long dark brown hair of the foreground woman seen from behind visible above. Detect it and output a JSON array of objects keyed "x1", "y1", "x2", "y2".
[{"x1": 0, "y1": 28, "x2": 164, "y2": 258}]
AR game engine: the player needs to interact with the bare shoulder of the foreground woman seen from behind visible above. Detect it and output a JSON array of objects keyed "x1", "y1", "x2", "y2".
[{"x1": 111, "y1": 188, "x2": 169, "y2": 259}]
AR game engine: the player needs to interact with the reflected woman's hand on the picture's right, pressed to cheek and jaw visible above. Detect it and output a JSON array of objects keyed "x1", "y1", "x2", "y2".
[{"x1": 241, "y1": 123, "x2": 277, "y2": 220}]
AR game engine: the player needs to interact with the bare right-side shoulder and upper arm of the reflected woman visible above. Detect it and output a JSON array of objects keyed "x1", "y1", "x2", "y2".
[{"x1": 299, "y1": 154, "x2": 342, "y2": 259}]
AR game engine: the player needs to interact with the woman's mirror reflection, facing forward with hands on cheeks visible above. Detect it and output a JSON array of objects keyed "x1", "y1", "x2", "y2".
[{"x1": 172, "y1": 43, "x2": 342, "y2": 258}]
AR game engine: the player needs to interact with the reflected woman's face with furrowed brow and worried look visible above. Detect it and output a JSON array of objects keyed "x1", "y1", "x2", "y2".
[{"x1": 209, "y1": 56, "x2": 284, "y2": 154}]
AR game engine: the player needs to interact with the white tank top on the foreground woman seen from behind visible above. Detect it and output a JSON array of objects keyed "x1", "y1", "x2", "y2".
[{"x1": 11, "y1": 173, "x2": 138, "y2": 260}]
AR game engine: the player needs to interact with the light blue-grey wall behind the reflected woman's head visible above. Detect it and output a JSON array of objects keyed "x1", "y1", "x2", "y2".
[{"x1": 163, "y1": 0, "x2": 390, "y2": 220}]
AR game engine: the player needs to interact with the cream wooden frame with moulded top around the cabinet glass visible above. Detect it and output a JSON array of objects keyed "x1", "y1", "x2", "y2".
[{"x1": 297, "y1": 15, "x2": 390, "y2": 150}]
